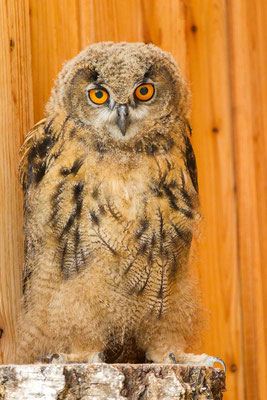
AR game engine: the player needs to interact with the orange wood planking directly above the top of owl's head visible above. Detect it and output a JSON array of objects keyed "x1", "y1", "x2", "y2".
[{"x1": 80, "y1": 0, "x2": 186, "y2": 74}]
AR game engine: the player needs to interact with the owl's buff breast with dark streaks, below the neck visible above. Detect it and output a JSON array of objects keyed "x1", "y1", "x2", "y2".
[{"x1": 38, "y1": 148, "x2": 196, "y2": 313}]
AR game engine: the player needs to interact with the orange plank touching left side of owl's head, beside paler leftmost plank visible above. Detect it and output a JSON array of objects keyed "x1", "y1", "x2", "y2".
[{"x1": 29, "y1": 0, "x2": 80, "y2": 122}]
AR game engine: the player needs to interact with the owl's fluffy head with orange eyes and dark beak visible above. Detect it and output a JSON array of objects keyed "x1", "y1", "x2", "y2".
[{"x1": 47, "y1": 42, "x2": 191, "y2": 142}]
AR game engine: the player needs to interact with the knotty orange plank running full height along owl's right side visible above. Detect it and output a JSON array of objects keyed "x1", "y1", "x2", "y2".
[{"x1": 186, "y1": 0, "x2": 244, "y2": 399}]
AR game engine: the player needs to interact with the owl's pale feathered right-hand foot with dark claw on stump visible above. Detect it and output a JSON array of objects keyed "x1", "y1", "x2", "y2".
[{"x1": 147, "y1": 352, "x2": 226, "y2": 372}]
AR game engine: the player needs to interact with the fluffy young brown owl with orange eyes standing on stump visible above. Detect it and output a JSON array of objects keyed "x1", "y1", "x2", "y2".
[{"x1": 17, "y1": 42, "x2": 225, "y2": 365}]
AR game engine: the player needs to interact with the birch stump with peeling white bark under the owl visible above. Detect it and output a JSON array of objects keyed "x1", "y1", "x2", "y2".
[{"x1": 0, "y1": 364, "x2": 225, "y2": 400}]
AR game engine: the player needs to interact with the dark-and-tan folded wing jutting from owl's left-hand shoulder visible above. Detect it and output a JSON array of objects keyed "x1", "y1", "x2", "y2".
[{"x1": 19, "y1": 118, "x2": 49, "y2": 191}]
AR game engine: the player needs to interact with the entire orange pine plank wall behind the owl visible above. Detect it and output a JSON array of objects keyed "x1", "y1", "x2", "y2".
[{"x1": 0, "y1": 0, "x2": 267, "y2": 400}]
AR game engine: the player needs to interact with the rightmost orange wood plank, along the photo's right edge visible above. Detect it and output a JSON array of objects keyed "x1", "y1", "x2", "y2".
[{"x1": 228, "y1": 0, "x2": 267, "y2": 400}]
